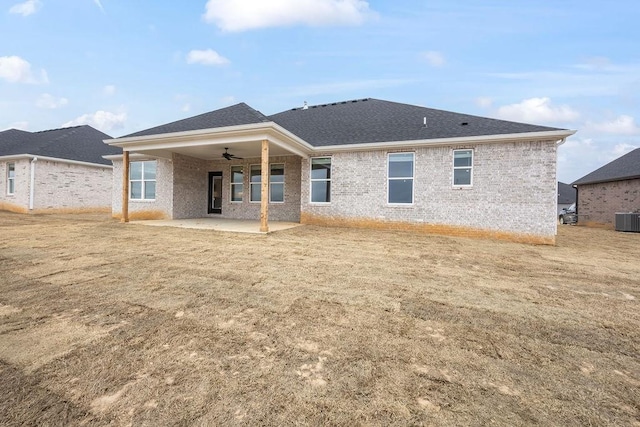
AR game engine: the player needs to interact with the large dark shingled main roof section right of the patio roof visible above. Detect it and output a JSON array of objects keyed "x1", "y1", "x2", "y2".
[{"x1": 269, "y1": 98, "x2": 563, "y2": 147}]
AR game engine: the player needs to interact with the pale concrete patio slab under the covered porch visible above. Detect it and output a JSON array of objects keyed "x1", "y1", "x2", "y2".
[{"x1": 131, "y1": 218, "x2": 302, "y2": 234}]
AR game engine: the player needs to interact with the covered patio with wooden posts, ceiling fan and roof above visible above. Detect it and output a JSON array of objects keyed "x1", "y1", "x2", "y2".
[{"x1": 105, "y1": 104, "x2": 312, "y2": 233}]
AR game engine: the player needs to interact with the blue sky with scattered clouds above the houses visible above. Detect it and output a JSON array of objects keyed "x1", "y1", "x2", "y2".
[{"x1": 0, "y1": 0, "x2": 640, "y2": 182}]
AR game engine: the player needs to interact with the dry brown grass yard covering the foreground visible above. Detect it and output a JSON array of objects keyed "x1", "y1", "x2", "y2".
[{"x1": 0, "y1": 213, "x2": 640, "y2": 426}]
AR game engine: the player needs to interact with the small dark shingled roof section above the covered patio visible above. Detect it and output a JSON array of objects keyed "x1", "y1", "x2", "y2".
[{"x1": 122, "y1": 102, "x2": 269, "y2": 138}]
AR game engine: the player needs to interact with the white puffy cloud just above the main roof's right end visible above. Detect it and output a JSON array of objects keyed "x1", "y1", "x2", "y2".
[{"x1": 496, "y1": 98, "x2": 580, "y2": 124}]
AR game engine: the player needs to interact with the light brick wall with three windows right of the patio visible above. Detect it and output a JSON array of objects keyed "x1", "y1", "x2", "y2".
[{"x1": 301, "y1": 141, "x2": 557, "y2": 243}]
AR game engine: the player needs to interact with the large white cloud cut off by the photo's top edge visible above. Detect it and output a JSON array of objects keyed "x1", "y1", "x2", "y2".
[{"x1": 203, "y1": 0, "x2": 375, "y2": 31}]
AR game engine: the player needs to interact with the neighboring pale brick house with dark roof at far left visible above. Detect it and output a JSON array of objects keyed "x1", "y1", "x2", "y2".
[{"x1": 0, "y1": 126, "x2": 122, "y2": 213}]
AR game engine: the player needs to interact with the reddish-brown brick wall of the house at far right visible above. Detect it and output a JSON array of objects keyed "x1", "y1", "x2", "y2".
[{"x1": 578, "y1": 179, "x2": 640, "y2": 226}]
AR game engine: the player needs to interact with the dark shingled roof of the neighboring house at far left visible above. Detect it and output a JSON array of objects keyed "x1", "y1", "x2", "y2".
[{"x1": 0, "y1": 125, "x2": 122, "y2": 165}]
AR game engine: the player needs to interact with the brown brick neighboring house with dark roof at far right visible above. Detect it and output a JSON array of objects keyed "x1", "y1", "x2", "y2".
[{"x1": 573, "y1": 148, "x2": 640, "y2": 226}]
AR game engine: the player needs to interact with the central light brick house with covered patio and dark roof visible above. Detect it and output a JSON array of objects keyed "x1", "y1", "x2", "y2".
[{"x1": 105, "y1": 99, "x2": 574, "y2": 243}]
